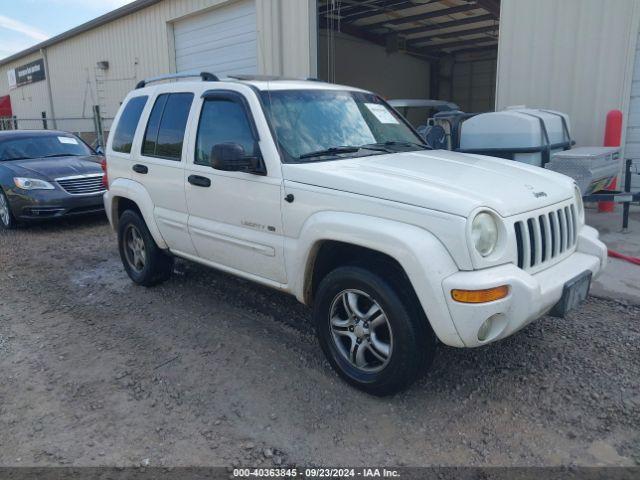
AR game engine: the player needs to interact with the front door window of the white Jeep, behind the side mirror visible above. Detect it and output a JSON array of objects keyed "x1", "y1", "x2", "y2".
[{"x1": 195, "y1": 99, "x2": 256, "y2": 166}]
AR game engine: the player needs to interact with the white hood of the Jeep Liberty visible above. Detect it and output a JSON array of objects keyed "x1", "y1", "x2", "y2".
[{"x1": 283, "y1": 150, "x2": 574, "y2": 217}]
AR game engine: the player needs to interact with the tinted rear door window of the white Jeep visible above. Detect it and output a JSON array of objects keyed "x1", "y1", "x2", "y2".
[{"x1": 142, "y1": 93, "x2": 193, "y2": 161}]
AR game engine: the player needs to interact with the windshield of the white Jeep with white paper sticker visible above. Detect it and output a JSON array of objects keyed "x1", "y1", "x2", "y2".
[{"x1": 262, "y1": 90, "x2": 427, "y2": 162}]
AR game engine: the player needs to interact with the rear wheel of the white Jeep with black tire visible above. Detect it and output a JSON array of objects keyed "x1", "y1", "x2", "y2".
[{"x1": 118, "y1": 210, "x2": 173, "y2": 287}]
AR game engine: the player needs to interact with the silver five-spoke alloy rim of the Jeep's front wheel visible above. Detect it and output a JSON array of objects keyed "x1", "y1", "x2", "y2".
[{"x1": 329, "y1": 290, "x2": 393, "y2": 373}]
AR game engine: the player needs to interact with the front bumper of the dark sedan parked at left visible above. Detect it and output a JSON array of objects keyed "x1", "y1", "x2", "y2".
[{"x1": 7, "y1": 188, "x2": 104, "y2": 221}]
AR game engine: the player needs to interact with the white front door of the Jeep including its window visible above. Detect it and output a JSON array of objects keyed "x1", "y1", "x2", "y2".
[{"x1": 185, "y1": 90, "x2": 286, "y2": 284}]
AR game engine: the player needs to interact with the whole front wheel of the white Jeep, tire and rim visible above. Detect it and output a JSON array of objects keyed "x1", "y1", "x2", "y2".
[{"x1": 314, "y1": 266, "x2": 436, "y2": 395}]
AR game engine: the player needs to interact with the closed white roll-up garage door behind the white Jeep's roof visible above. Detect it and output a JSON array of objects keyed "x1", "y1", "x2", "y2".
[{"x1": 173, "y1": 0, "x2": 258, "y2": 75}]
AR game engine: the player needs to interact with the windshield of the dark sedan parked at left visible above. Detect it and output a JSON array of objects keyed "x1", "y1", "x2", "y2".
[{"x1": 0, "y1": 134, "x2": 94, "y2": 161}]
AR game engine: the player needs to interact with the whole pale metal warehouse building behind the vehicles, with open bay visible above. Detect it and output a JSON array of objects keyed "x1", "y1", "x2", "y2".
[{"x1": 0, "y1": 0, "x2": 640, "y2": 188}]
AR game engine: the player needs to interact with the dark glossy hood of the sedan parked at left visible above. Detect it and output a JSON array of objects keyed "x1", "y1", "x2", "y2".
[{"x1": 0, "y1": 156, "x2": 102, "y2": 180}]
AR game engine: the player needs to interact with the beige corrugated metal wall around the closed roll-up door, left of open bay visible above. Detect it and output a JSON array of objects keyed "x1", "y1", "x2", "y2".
[{"x1": 0, "y1": 0, "x2": 315, "y2": 131}]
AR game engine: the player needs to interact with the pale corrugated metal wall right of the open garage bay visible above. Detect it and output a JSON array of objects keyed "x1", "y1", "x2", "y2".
[{"x1": 496, "y1": 0, "x2": 640, "y2": 145}]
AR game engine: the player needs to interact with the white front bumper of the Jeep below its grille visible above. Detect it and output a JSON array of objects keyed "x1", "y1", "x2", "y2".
[{"x1": 442, "y1": 226, "x2": 607, "y2": 347}]
